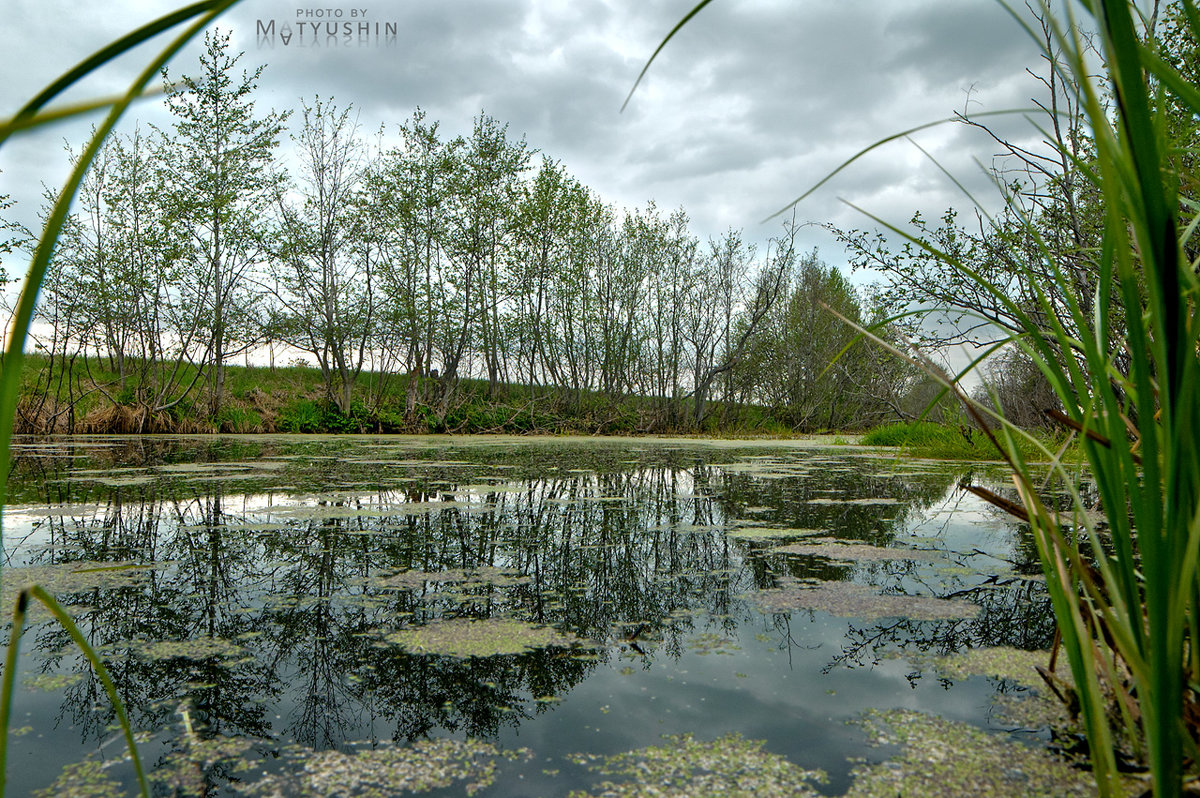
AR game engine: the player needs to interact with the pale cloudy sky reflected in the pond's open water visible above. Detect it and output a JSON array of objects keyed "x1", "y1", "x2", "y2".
[{"x1": 5, "y1": 440, "x2": 1051, "y2": 796}]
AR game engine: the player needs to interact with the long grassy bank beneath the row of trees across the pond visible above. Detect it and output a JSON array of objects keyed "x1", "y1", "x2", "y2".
[{"x1": 17, "y1": 355, "x2": 800, "y2": 436}]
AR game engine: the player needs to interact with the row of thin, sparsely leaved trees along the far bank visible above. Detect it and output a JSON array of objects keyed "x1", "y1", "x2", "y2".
[{"x1": 0, "y1": 35, "x2": 920, "y2": 432}]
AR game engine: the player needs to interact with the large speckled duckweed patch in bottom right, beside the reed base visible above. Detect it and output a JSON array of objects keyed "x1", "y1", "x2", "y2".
[{"x1": 846, "y1": 709, "x2": 1096, "y2": 798}]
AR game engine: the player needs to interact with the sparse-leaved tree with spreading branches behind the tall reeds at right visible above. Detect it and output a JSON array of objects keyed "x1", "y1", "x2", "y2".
[{"x1": 833, "y1": 7, "x2": 1120, "y2": 379}]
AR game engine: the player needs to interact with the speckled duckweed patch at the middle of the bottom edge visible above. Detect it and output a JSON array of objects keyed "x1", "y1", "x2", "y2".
[{"x1": 568, "y1": 734, "x2": 826, "y2": 798}]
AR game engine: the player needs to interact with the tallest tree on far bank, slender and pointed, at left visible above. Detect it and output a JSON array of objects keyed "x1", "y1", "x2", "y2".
[{"x1": 162, "y1": 32, "x2": 287, "y2": 416}]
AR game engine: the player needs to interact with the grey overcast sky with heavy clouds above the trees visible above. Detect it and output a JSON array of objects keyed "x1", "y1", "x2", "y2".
[{"x1": 0, "y1": 0, "x2": 1038, "y2": 273}]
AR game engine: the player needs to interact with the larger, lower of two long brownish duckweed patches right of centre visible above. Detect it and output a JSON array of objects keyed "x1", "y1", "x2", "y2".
[{"x1": 751, "y1": 580, "x2": 979, "y2": 620}]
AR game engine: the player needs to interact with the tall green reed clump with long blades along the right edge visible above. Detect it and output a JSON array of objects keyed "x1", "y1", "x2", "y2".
[{"x1": 940, "y1": 0, "x2": 1200, "y2": 796}]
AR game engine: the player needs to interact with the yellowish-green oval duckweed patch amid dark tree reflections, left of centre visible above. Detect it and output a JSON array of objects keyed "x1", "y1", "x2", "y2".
[{"x1": 384, "y1": 618, "x2": 584, "y2": 659}]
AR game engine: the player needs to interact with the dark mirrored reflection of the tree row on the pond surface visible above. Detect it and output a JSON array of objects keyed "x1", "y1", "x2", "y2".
[{"x1": 5, "y1": 440, "x2": 1052, "y2": 784}]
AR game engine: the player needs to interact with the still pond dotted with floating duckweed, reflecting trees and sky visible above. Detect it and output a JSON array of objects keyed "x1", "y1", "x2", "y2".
[{"x1": 4, "y1": 436, "x2": 1094, "y2": 796}]
